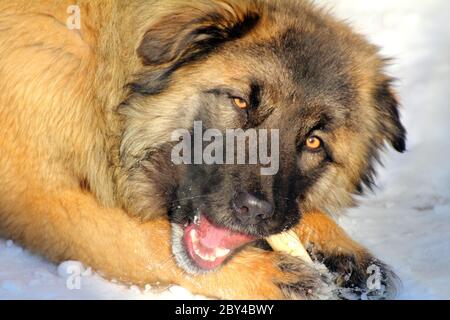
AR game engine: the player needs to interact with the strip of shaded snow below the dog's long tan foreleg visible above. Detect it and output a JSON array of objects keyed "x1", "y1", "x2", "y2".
[{"x1": 0, "y1": 241, "x2": 201, "y2": 300}]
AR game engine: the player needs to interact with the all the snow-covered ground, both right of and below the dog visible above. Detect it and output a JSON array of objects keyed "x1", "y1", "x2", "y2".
[{"x1": 0, "y1": 0, "x2": 450, "y2": 299}]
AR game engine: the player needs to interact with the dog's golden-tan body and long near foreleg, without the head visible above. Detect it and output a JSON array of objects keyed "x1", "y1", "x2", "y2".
[{"x1": 0, "y1": 1, "x2": 316, "y2": 298}]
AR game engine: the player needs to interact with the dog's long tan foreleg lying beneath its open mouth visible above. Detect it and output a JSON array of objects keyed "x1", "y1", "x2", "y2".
[{"x1": 0, "y1": 189, "x2": 334, "y2": 299}]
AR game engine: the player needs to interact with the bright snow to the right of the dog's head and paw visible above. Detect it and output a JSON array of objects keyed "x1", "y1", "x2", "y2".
[{"x1": 316, "y1": 0, "x2": 450, "y2": 299}]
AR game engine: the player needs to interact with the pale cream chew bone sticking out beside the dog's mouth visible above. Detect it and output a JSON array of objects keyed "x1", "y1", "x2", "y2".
[{"x1": 266, "y1": 231, "x2": 313, "y2": 264}]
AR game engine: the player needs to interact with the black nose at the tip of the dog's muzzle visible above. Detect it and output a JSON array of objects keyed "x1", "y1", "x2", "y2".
[{"x1": 233, "y1": 192, "x2": 274, "y2": 225}]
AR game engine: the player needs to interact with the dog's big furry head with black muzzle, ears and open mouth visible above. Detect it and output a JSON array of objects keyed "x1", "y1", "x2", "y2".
[{"x1": 119, "y1": 1, "x2": 405, "y2": 273}]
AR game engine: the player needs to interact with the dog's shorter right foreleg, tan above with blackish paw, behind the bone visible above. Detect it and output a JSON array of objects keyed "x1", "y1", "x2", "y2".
[{"x1": 296, "y1": 212, "x2": 398, "y2": 299}]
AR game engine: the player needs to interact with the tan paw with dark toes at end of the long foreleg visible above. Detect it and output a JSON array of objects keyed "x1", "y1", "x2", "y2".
[{"x1": 276, "y1": 255, "x2": 338, "y2": 300}]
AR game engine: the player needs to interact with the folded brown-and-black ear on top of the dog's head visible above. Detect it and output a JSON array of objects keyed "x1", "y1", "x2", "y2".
[{"x1": 137, "y1": 0, "x2": 259, "y2": 66}]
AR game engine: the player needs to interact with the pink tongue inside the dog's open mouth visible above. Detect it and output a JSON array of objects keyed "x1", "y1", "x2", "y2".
[{"x1": 197, "y1": 215, "x2": 255, "y2": 250}]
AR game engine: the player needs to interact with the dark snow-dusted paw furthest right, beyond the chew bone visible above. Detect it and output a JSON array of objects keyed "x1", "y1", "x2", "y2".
[{"x1": 320, "y1": 253, "x2": 400, "y2": 300}]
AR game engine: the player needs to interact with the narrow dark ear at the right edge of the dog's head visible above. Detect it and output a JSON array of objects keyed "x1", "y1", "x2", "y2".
[{"x1": 375, "y1": 79, "x2": 406, "y2": 152}]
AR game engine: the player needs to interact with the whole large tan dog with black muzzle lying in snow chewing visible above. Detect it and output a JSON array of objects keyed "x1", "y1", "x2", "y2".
[{"x1": 0, "y1": 0, "x2": 405, "y2": 299}]
